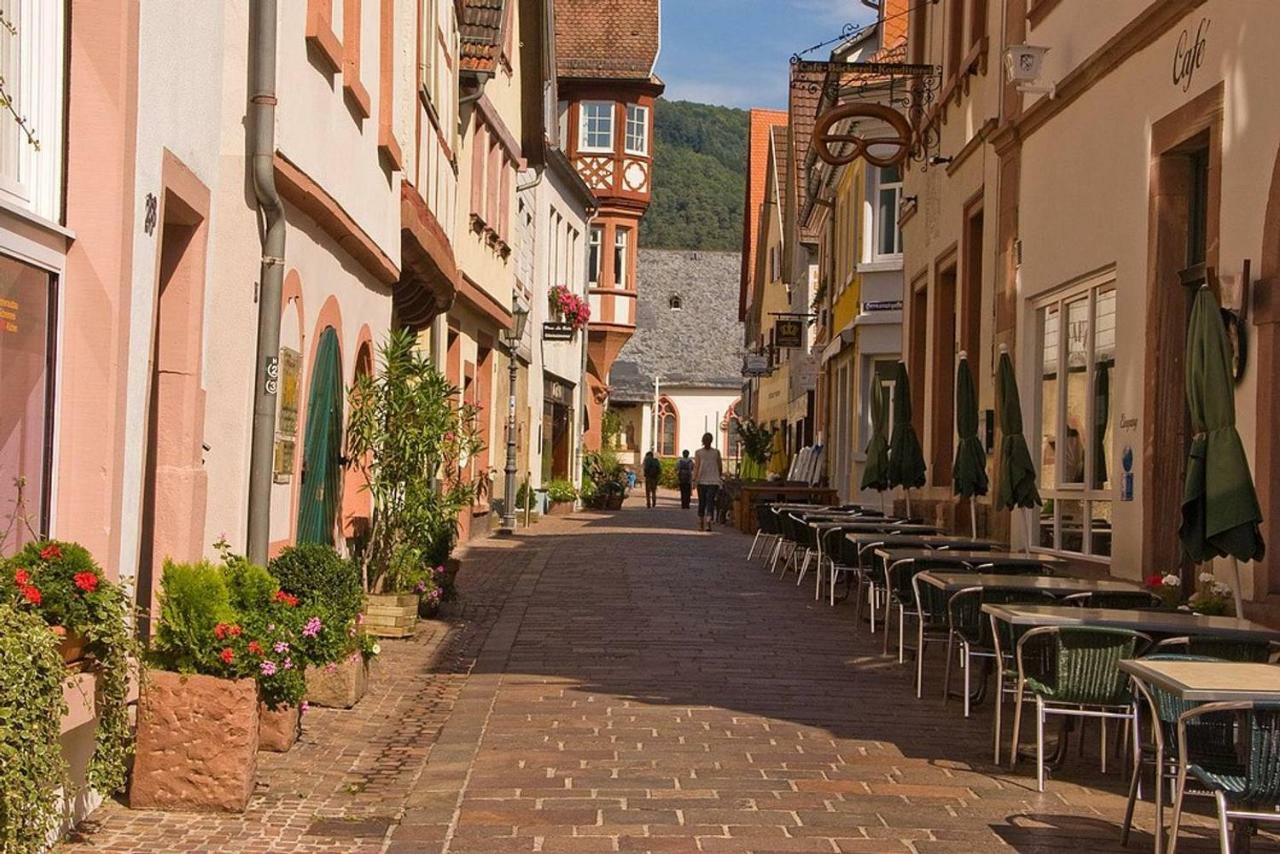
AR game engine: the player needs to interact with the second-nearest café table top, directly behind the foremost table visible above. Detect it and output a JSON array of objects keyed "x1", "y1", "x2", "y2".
[{"x1": 982, "y1": 603, "x2": 1280, "y2": 640}]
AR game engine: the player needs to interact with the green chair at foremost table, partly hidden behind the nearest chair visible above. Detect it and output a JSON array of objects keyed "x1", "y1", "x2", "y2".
[{"x1": 1120, "y1": 644, "x2": 1235, "y2": 854}]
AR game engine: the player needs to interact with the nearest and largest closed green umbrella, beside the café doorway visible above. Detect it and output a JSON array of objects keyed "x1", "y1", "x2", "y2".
[{"x1": 1178, "y1": 287, "x2": 1266, "y2": 616}]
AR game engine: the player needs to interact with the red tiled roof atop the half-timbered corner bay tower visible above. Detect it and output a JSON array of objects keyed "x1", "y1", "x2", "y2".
[{"x1": 556, "y1": 0, "x2": 660, "y2": 81}]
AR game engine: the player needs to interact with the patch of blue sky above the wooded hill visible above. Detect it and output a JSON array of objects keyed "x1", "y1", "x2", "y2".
[{"x1": 658, "y1": 0, "x2": 876, "y2": 109}]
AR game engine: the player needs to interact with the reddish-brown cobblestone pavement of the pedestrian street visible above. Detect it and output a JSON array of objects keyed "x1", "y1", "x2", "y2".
[{"x1": 65, "y1": 497, "x2": 1280, "y2": 854}]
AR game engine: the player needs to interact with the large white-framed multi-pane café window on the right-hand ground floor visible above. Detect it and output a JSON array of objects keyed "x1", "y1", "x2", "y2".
[{"x1": 1033, "y1": 273, "x2": 1117, "y2": 558}]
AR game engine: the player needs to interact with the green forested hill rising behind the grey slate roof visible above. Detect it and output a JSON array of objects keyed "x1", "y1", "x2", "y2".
[{"x1": 640, "y1": 100, "x2": 748, "y2": 251}]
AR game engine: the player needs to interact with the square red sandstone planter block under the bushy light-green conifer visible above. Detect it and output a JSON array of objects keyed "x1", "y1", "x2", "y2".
[{"x1": 129, "y1": 671, "x2": 260, "y2": 812}]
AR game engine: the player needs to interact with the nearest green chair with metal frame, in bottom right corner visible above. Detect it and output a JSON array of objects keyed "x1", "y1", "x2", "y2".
[{"x1": 1169, "y1": 702, "x2": 1280, "y2": 854}]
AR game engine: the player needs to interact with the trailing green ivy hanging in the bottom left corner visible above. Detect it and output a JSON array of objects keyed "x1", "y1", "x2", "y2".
[{"x1": 0, "y1": 603, "x2": 67, "y2": 851}]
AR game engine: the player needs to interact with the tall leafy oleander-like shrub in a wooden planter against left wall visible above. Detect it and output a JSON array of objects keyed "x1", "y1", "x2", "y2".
[{"x1": 347, "y1": 330, "x2": 484, "y2": 638}]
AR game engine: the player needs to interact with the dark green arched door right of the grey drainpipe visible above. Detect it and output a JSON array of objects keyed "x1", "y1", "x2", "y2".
[{"x1": 298, "y1": 326, "x2": 342, "y2": 545}]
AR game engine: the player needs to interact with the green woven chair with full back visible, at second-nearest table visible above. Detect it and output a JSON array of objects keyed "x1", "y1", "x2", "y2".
[{"x1": 1009, "y1": 626, "x2": 1151, "y2": 791}]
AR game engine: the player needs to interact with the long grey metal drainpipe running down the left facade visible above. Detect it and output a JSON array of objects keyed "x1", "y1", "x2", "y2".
[{"x1": 247, "y1": 0, "x2": 284, "y2": 566}]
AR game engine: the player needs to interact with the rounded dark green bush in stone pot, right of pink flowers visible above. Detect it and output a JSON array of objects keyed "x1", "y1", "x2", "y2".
[{"x1": 264, "y1": 543, "x2": 378, "y2": 730}]
